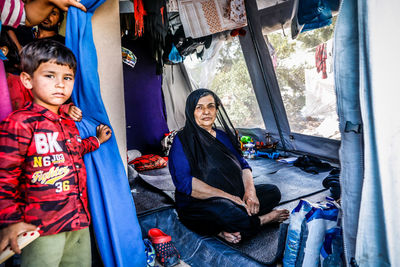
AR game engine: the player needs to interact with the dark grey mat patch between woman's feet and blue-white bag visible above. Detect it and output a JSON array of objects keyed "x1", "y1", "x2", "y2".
[{"x1": 223, "y1": 223, "x2": 288, "y2": 264}]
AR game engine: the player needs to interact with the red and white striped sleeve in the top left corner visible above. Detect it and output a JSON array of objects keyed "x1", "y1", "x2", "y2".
[{"x1": 0, "y1": 0, "x2": 25, "y2": 28}]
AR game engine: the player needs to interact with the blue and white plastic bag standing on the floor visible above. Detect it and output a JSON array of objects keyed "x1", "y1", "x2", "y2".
[{"x1": 283, "y1": 199, "x2": 343, "y2": 267}]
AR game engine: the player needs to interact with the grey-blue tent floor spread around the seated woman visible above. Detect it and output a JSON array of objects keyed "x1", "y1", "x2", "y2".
[{"x1": 130, "y1": 158, "x2": 330, "y2": 267}]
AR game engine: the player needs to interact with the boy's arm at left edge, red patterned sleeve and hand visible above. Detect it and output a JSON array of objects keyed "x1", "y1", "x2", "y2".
[{"x1": 0, "y1": 118, "x2": 37, "y2": 253}]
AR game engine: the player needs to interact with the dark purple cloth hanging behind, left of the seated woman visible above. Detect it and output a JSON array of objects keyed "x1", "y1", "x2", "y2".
[{"x1": 122, "y1": 37, "x2": 169, "y2": 155}]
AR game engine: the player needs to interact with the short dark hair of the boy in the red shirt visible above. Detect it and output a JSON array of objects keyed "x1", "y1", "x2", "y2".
[{"x1": 20, "y1": 39, "x2": 76, "y2": 76}]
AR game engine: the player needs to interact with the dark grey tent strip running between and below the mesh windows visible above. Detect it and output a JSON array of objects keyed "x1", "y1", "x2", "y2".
[{"x1": 240, "y1": 0, "x2": 340, "y2": 160}]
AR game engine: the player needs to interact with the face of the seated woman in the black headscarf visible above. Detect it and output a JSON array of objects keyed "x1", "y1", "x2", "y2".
[{"x1": 194, "y1": 95, "x2": 217, "y2": 131}]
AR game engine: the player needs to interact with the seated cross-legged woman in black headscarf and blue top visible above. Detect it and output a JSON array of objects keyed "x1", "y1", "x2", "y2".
[{"x1": 169, "y1": 89, "x2": 289, "y2": 243}]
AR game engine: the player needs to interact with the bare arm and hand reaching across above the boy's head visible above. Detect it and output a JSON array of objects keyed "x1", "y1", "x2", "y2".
[{"x1": 25, "y1": 0, "x2": 86, "y2": 26}]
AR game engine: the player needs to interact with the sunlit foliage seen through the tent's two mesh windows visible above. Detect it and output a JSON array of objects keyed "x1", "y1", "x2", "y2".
[{"x1": 186, "y1": 18, "x2": 336, "y2": 131}]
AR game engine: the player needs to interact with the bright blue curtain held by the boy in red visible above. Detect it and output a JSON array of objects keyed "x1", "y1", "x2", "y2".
[{"x1": 66, "y1": 0, "x2": 146, "y2": 267}]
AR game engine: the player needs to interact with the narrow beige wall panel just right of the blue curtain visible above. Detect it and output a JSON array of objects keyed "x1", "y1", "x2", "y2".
[{"x1": 92, "y1": 0, "x2": 126, "y2": 167}]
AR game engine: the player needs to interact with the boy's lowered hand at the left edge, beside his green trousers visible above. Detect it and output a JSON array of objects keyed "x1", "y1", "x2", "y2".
[{"x1": 0, "y1": 222, "x2": 39, "y2": 254}]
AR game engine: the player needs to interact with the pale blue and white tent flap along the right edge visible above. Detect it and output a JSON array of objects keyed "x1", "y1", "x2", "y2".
[{"x1": 335, "y1": 0, "x2": 400, "y2": 267}]
